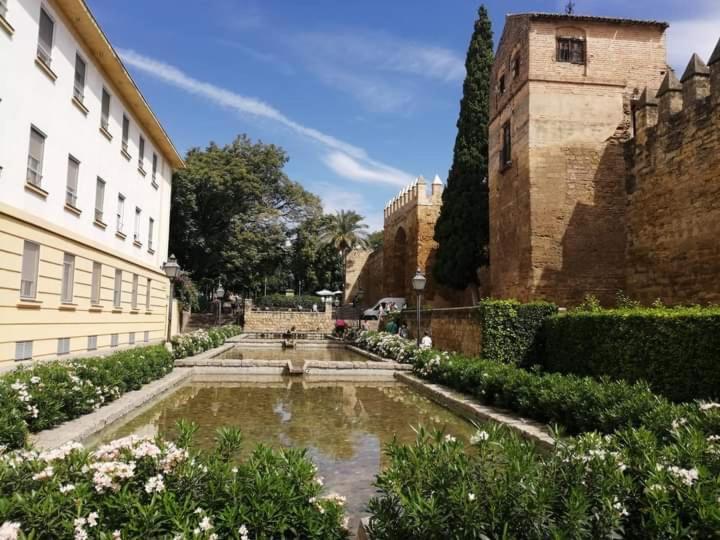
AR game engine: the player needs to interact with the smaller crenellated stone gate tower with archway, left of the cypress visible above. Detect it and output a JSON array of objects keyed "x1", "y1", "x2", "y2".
[{"x1": 383, "y1": 175, "x2": 443, "y2": 303}]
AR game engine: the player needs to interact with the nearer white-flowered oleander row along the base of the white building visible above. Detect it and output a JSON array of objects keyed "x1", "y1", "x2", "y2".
[{"x1": 0, "y1": 346, "x2": 173, "y2": 448}]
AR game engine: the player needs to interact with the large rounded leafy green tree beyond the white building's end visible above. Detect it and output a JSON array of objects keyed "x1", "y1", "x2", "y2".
[{"x1": 170, "y1": 135, "x2": 321, "y2": 293}]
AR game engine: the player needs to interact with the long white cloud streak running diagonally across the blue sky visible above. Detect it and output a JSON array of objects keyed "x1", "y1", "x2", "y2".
[{"x1": 118, "y1": 49, "x2": 410, "y2": 183}]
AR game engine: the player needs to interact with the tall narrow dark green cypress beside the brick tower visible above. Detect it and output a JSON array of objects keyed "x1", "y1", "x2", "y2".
[{"x1": 433, "y1": 5, "x2": 494, "y2": 289}]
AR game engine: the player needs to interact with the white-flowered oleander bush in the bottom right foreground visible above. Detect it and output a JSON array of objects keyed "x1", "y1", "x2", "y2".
[{"x1": 369, "y1": 426, "x2": 720, "y2": 540}]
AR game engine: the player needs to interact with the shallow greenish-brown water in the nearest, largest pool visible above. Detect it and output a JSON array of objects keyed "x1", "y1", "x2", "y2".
[{"x1": 89, "y1": 377, "x2": 474, "y2": 530}]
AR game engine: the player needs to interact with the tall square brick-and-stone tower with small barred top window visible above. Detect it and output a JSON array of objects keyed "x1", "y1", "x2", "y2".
[{"x1": 489, "y1": 13, "x2": 668, "y2": 305}]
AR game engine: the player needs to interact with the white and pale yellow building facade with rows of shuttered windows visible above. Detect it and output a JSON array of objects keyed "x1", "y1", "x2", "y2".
[{"x1": 0, "y1": 0, "x2": 183, "y2": 362}]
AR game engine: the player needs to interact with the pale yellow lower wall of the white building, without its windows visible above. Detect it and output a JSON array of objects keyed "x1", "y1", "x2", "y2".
[{"x1": 0, "y1": 209, "x2": 169, "y2": 362}]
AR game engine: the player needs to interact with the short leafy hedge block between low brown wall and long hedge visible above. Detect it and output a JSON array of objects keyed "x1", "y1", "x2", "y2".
[{"x1": 477, "y1": 300, "x2": 557, "y2": 366}]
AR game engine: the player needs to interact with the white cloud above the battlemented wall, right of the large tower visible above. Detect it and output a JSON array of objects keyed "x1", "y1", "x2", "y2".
[{"x1": 667, "y1": 18, "x2": 720, "y2": 73}]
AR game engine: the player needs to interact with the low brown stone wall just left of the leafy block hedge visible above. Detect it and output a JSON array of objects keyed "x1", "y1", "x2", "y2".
[{"x1": 404, "y1": 307, "x2": 482, "y2": 356}]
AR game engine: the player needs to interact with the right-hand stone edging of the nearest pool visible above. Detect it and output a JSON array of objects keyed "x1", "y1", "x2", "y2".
[{"x1": 395, "y1": 373, "x2": 555, "y2": 449}]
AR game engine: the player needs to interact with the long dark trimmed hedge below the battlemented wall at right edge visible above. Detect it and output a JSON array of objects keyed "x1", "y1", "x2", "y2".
[{"x1": 543, "y1": 307, "x2": 720, "y2": 402}]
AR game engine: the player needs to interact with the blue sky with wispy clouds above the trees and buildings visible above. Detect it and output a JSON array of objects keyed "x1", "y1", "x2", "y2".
[{"x1": 87, "y1": 0, "x2": 720, "y2": 230}]
